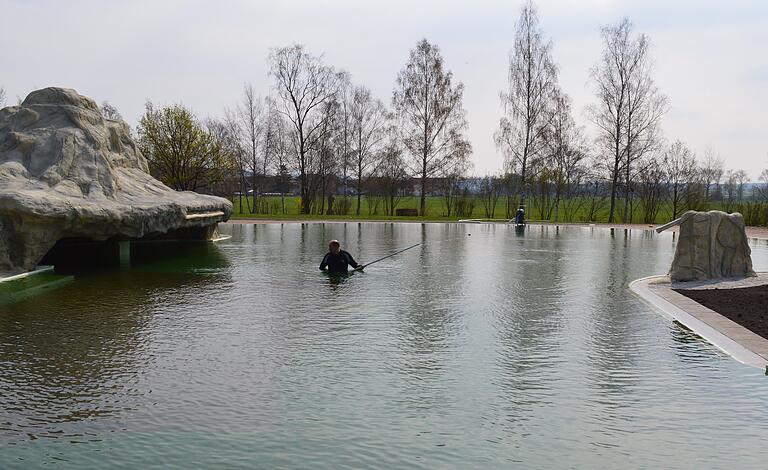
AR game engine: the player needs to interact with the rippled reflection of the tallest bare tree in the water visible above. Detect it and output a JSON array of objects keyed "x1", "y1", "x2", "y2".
[{"x1": 488, "y1": 229, "x2": 568, "y2": 422}]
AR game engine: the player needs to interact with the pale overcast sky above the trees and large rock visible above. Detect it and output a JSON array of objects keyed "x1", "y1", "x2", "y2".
[{"x1": 0, "y1": 0, "x2": 768, "y2": 179}]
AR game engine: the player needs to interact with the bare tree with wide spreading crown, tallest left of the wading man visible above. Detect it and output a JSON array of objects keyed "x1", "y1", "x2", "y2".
[{"x1": 269, "y1": 45, "x2": 343, "y2": 214}]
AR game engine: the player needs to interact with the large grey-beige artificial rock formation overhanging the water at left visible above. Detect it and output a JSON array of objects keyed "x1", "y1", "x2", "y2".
[{"x1": 0, "y1": 88, "x2": 232, "y2": 273}]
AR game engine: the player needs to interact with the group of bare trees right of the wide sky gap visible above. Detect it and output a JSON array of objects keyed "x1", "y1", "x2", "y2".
[{"x1": 492, "y1": 1, "x2": 768, "y2": 226}]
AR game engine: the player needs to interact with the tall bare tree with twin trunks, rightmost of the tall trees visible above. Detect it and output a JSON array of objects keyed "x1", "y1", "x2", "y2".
[{"x1": 589, "y1": 18, "x2": 667, "y2": 222}]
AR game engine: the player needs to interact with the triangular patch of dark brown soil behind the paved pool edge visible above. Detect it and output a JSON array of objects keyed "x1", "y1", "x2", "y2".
[{"x1": 674, "y1": 284, "x2": 768, "y2": 339}]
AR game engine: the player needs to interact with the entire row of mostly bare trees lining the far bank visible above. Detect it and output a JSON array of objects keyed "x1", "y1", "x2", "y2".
[{"x1": 124, "y1": 1, "x2": 768, "y2": 222}]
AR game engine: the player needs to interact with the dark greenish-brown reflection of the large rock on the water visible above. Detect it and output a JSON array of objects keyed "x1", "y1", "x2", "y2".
[{"x1": 0, "y1": 242, "x2": 228, "y2": 444}]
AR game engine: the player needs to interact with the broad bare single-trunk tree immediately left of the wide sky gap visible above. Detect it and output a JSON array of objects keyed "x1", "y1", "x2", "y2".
[{"x1": 392, "y1": 39, "x2": 471, "y2": 216}]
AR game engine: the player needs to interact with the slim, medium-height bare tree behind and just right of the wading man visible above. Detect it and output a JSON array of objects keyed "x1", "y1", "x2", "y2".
[{"x1": 350, "y1": 86, "x2": 389, "y2": 215}]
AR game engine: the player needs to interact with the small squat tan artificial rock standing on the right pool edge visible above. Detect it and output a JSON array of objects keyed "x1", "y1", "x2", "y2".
[{"x1": 669, "y1": 211, "x2": 755, "y2": 281}]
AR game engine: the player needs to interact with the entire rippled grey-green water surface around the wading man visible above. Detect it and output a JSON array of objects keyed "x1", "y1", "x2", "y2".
[{"x1": 0, "y1": 223, "x2": 768, "y2": 469}]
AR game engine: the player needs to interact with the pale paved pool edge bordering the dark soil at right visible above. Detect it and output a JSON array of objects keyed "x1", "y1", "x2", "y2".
[{"x1": 629, "y1": 273, "x2": 768, "y2": 374}]
